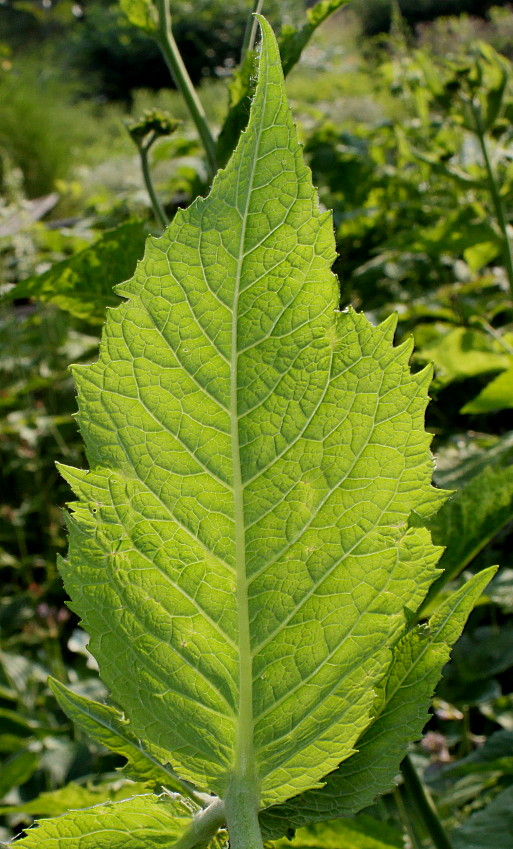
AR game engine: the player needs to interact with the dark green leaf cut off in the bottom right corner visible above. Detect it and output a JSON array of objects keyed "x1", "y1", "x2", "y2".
[{"x1": 451, "y1": 787, "x2": 513, "y2": 849}]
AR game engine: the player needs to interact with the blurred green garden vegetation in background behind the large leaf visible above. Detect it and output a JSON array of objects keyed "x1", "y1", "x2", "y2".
[{"x1": 0, "y1": 0, "x2": 513, "y2": 849}]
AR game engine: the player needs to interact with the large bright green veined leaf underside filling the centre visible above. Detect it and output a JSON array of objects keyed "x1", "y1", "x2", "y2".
[{"x1": 61, "y1": 18, "x2": 439, "y2": 806}]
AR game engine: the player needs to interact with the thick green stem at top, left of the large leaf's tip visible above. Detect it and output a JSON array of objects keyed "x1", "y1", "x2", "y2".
[{"x1": 157, "y1": 0, "x2": 217, "y2": 178}]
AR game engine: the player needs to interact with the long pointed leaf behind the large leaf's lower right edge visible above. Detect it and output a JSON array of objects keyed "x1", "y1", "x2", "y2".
[{"x1": 261, "y1": 567, "x2": 496, "y2": 837}]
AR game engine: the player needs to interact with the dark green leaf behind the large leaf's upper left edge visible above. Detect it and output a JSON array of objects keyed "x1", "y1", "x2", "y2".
[{"x1": 8, "y1": 221, "x2": 148, "y2": 324}]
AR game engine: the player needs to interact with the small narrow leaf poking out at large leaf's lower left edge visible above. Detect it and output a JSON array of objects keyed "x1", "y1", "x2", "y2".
[{"x1": 49, "y1": 678, "x2": 189, "y2": 791}]
